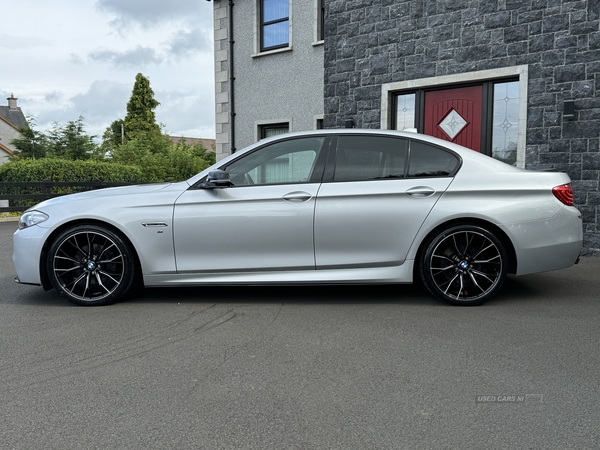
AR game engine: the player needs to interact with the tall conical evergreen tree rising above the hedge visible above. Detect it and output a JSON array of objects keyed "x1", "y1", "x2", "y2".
[{"x1": 123, "y1": 73, "x2": 161, "y2": 139}]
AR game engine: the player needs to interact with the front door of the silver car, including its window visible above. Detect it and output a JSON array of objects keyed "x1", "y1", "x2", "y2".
[{"x1": 174, "y1": 136, "x2": 325, "y2": 273}]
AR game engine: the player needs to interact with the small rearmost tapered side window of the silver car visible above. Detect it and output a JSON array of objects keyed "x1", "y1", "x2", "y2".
[{"x1": 408, "y1": 141, "x2": 460, "y2": 178}]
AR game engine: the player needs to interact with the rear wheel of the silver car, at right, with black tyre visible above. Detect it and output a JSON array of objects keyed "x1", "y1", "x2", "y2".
[{"x1": 419, "y1": 225, "x2": 508, "y2": 305}]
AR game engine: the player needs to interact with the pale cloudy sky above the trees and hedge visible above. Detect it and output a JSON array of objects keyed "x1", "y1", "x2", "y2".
[{"x1": 0, "y1": 0, "x2": 215, "y2": 138}]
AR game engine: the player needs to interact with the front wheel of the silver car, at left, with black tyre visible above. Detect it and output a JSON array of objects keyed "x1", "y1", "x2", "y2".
[{"x1": 46, "y1": 225, "x2": 135, "y2": 306}]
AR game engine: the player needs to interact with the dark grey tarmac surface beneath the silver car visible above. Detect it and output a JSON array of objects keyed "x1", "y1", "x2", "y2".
[{"x1": 0, "y1": 222, "x2": 600, "y2": 450}]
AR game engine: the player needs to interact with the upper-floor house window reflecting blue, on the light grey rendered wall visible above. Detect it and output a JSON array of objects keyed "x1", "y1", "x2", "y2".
[{"x1": 260, "y1": 0, "x2": 290, "y2": 51}]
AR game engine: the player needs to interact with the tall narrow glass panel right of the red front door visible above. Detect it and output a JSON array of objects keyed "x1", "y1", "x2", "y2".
[{"x1": 492, "y1": 81, "x2": 519, "y2": 164}]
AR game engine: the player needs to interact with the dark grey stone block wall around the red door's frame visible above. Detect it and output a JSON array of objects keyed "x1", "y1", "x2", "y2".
[{"x1": 324, "y1": 0, "x2": 600, "y2": 255}]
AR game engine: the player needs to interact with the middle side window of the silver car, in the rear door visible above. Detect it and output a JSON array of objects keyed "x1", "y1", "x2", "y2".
[{"x1": 333, "y1": 136, "x2": 408, "y2": 181}]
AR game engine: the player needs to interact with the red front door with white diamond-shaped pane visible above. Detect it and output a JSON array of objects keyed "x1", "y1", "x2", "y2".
[{"x1": 424, "y1": 86, "x2": 483, "y2": 151}]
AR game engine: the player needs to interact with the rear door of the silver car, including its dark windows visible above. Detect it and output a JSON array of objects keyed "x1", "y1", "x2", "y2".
[{"x1": 315, "y1": 135, "x2": 460, "y2": 269}]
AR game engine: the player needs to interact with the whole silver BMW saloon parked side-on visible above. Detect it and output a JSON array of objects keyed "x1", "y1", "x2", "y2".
[{"x1": 13, "y1": 130, "x2": 583, "y2": 305}]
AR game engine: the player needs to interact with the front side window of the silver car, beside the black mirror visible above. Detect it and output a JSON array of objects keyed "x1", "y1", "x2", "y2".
[{"x1": 225, "y1": 137, "x2": 325, "y2": 186}]
